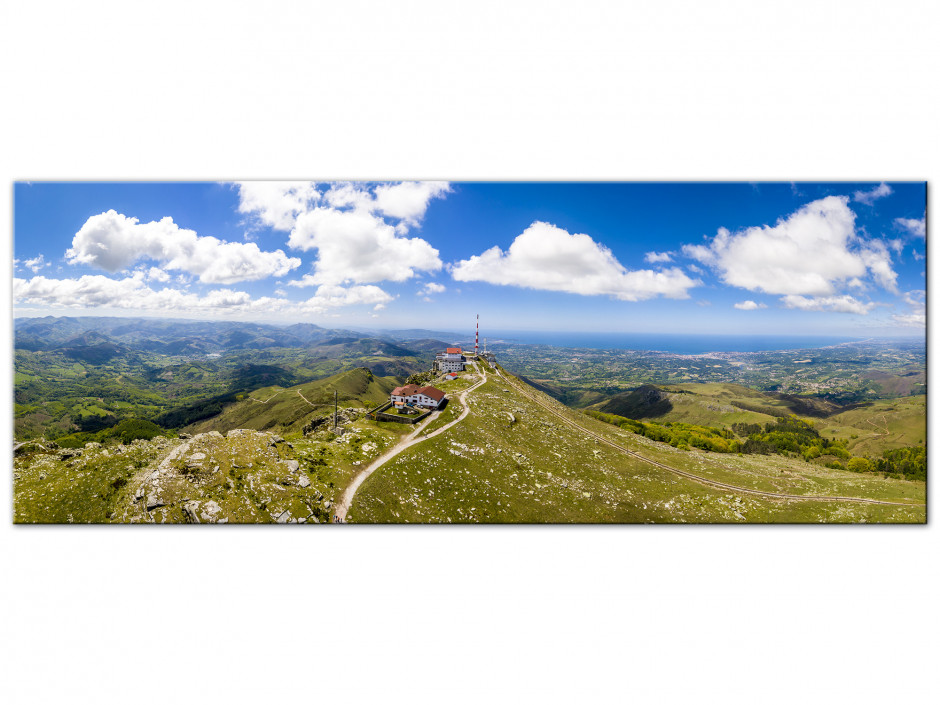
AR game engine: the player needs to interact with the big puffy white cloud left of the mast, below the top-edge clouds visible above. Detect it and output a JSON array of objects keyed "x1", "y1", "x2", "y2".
[{"x1": 288, "y1": 208, "x2": 443, "y2": 284}]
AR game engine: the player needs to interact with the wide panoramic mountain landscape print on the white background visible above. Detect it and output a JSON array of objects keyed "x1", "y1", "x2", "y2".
[{"x1": 12, "y1": 181, "x2": 927, "y2": 525}]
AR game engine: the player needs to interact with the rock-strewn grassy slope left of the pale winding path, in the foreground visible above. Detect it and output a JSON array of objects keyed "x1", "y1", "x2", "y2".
[{"x1": 13, "y1": 421, "x2": 410, "y2": 523}]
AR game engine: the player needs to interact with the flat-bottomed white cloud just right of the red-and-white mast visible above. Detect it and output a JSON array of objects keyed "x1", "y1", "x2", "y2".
[{"x1": 451, "y1": 221, "x2": 699, "y2": 301}]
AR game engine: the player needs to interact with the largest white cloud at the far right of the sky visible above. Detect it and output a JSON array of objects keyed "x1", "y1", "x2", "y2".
[{"x1": 682, "y1": 196, "x2": 897, "y2": 296}]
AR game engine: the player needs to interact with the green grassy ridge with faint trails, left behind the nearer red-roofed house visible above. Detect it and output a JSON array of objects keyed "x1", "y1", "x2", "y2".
[{"x1": 184, "y1": 367, "x2": 399, "y2": 435}]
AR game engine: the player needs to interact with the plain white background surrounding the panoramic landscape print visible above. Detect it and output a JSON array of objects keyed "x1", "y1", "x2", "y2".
[{"x1": 0, "y1": 0, "x2": 940, "y2": 703}]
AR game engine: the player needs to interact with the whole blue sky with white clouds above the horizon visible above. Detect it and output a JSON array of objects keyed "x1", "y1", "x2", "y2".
[{"x1": 14, "y1": 182, "x2": 926, "y2": 336}]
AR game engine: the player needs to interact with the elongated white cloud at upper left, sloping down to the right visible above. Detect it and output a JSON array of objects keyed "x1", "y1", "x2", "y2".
[{"x1": 66, "y1": 210, "x2": 300, "y2": 284}]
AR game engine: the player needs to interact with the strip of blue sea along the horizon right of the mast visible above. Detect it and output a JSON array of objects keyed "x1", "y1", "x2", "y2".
[{"x1": 492, "y1": 331, "x2": 865, "y2": 355}]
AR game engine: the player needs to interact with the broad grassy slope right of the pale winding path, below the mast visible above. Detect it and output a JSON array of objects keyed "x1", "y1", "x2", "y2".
[{"x1": 348, "y1": 368, "x2": 925, "y2": 523}]
